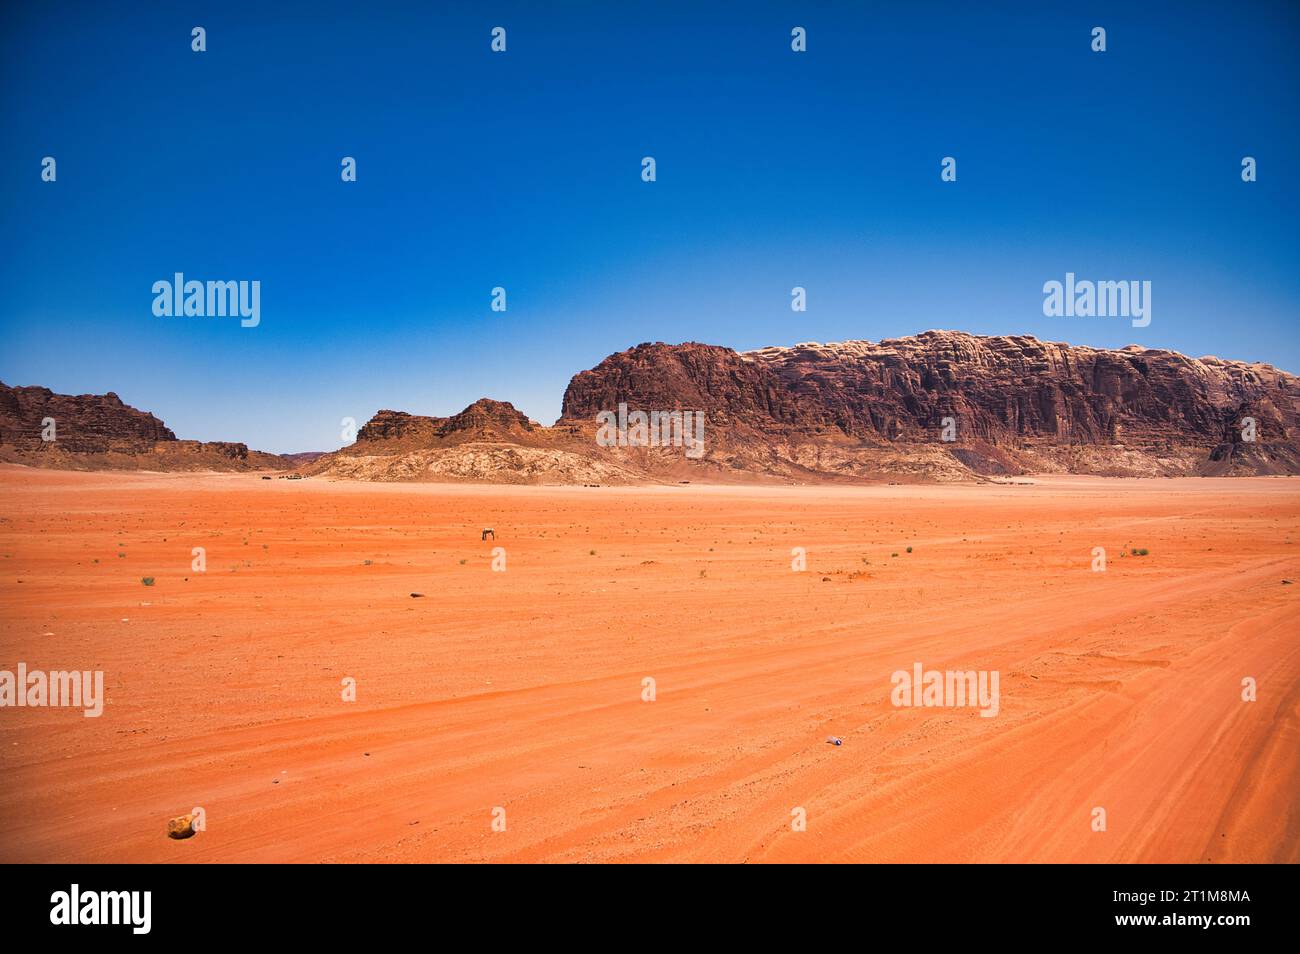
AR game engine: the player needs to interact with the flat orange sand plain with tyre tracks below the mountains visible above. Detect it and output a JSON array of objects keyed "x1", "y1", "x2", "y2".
[{"x1": 0, "y1": 468, "x2": 1300, "y2": 862}]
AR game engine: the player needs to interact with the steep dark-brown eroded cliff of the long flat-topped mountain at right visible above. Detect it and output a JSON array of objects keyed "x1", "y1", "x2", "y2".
[{"x1": 562, "y1": 331, "x2": 1300, "y2": 474}]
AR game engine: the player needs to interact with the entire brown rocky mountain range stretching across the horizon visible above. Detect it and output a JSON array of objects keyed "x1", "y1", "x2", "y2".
[{"x1": 10, "y1": 331, "x2": 1300, "y2": 483}]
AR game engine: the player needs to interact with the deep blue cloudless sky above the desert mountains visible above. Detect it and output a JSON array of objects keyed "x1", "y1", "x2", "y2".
[{"x1": 0, "y1": 0, "x2": 1300, "y2": 451}]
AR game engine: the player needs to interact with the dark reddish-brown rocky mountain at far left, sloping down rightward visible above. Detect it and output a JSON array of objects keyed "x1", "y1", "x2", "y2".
[{"x1": 0, "y1": 382, "x2": 291, "y2": 471}]
